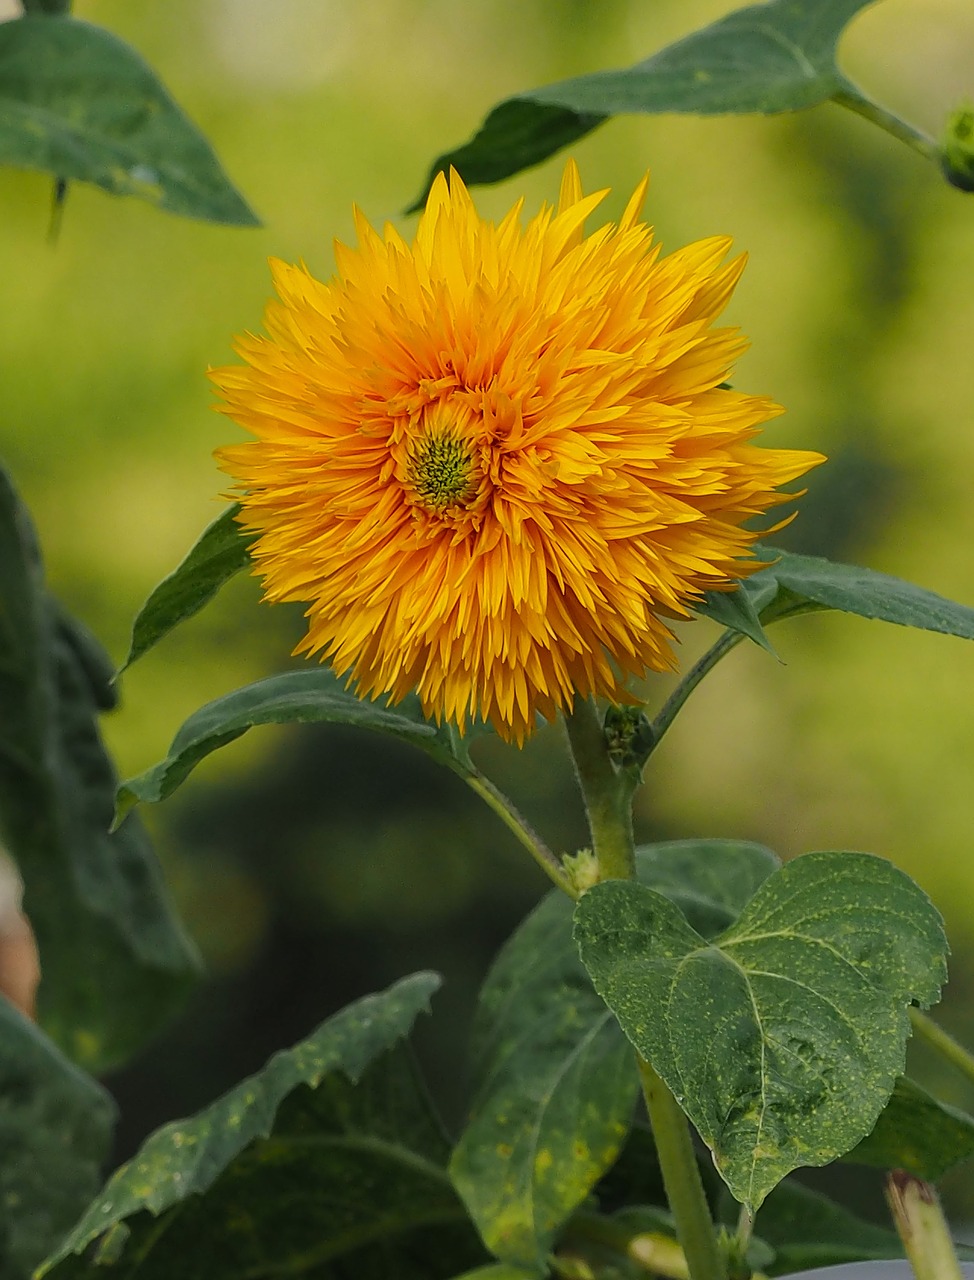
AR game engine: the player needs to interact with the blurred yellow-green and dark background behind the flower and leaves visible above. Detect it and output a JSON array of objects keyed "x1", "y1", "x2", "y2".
[{"x1": 0, "y1": 0, "x2": 974, "y2": 1216}]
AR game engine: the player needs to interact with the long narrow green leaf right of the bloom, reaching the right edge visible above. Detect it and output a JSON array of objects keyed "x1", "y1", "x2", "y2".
[{"x1": 744, "y1": 547, "x2": 974, "y2": 640}]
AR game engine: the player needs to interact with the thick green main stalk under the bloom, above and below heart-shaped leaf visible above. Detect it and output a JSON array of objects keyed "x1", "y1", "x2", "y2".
[{"x1": 564, "y1": 698, "x2": 726, "y2": 1280}]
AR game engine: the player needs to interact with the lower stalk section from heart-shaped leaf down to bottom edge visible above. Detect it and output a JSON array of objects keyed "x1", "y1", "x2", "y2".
[{"x1": 639, "y1": 1057, "x2": 724, "y2": 1280}]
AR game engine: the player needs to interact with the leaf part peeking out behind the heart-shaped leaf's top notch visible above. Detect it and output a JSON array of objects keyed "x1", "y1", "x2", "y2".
[{"x1": 636, "y1": 840, "x2": 781, "y2": 938}]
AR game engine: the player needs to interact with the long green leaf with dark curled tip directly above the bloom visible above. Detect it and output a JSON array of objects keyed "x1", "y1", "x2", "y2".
[{"x1": 411, "y1": 0, "x2": 872, "y2": 200}]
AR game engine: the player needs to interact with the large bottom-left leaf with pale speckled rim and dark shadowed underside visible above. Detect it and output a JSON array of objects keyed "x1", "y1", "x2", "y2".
[{"x1": 38, "y1": 973, "x2": 485, "y2": 1280}]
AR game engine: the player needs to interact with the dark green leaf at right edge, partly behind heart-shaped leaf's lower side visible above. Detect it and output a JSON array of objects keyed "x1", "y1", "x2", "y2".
[{"x1": 845, "y1": 1076, "x2": 974, "y2": 1183}]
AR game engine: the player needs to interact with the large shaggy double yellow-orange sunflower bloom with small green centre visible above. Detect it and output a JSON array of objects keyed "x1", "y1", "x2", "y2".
[{"x1": 212, "y1": 163, "x2": 822, "y2": 742}]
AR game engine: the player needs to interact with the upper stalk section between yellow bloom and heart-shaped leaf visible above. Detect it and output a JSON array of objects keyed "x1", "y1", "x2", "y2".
[{"x1": 564, "y1": 698, "x2": 636, "y2": 879}]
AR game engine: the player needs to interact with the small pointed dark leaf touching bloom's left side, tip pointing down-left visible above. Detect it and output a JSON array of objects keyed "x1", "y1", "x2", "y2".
[{"x1": 119, "y1": 502, "x2": 256, "y2": 675}]
